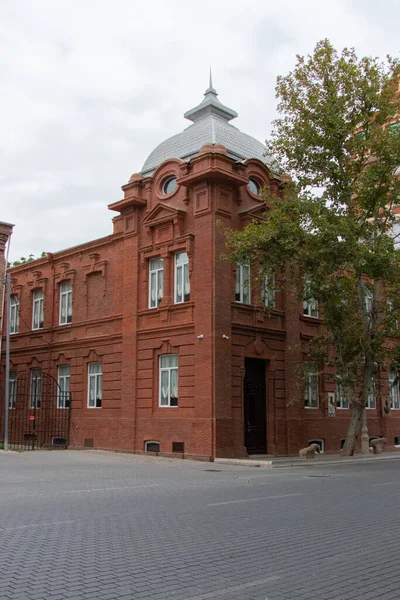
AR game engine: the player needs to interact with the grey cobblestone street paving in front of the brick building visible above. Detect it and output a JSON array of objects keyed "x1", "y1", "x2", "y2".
[{"x1": 0, "y1": 451, "x2": 400, "y2": 600}]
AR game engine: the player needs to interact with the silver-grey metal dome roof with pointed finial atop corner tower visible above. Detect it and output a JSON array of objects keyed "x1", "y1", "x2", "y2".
[{"x1": 142, "y1": 76, "x2": 273, "y2": 176}]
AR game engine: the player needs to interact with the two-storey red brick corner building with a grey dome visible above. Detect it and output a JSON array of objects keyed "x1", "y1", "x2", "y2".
[{"x1": 3, "y1": 83, "x2": 400, "y2": 459}]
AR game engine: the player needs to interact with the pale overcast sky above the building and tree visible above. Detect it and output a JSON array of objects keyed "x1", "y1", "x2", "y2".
[{"x1": 0, "y1": 0, "x2": 400, "y2": 260}]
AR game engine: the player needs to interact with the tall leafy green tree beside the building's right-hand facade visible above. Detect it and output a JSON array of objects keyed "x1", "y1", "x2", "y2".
[{"x1": 228, "y1": 40, "x2": 400, "y2": 455}]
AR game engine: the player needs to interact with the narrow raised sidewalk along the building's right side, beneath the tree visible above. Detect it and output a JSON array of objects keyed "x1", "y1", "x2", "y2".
[{"x1": 214, "y1": 450, "x2": 400, "y2": 469}]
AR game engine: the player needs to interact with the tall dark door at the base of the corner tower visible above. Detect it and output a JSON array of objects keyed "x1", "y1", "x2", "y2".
[{"x1": 244, "y1": 358, "x2": 267, "y2": 454}]
